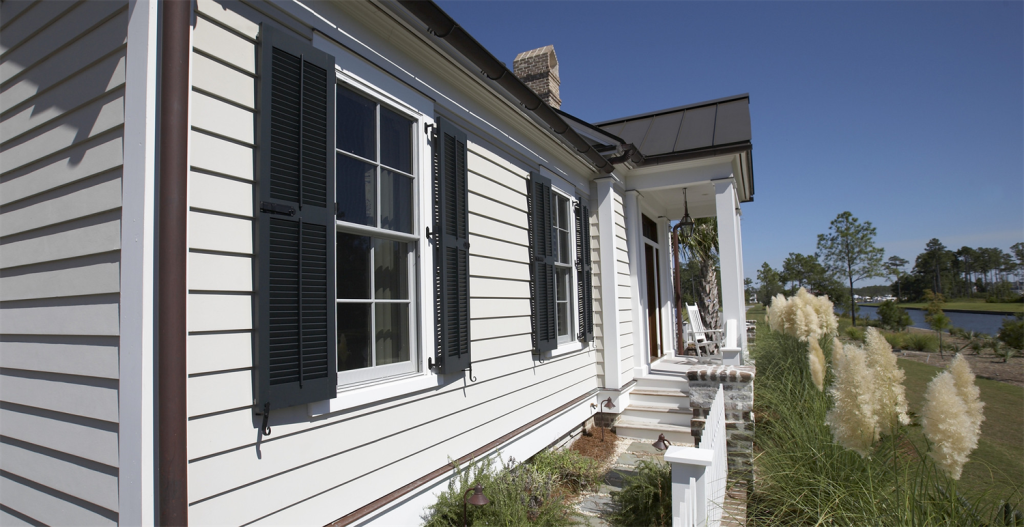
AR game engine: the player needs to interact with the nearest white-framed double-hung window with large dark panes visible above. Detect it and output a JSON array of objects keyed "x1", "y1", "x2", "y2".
[{"x1": 336, "y1": 85, "x2": 419, "y2": 384}]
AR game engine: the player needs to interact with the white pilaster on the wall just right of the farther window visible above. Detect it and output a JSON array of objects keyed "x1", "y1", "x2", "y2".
[{"x1": 595, "y1": 176, "x2": 623, "y2": 390}]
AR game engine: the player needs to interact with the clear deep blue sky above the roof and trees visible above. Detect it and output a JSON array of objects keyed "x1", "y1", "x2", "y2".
[{"x1": 437, "y1": 0, "x2": 1024, "y2": 286}]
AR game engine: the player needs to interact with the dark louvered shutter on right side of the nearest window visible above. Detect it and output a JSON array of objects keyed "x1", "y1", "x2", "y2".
[{"x1": 434, "y1": 119, "x2": 471, "y2": 374}]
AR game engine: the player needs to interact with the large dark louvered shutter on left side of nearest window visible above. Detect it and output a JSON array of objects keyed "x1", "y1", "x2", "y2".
[{"x1": 253, "y1": 25, "x2": 338, "y2": 411}]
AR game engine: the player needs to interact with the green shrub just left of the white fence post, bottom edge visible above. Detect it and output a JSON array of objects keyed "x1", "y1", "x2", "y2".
[{"x1": 608, "y1": 459, "x2": 672, "y2": 527}]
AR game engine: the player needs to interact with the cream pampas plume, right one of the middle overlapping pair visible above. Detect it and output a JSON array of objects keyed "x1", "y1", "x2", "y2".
[{"x1": 864, "y1": 327, "x2": 909, "y2": 434}]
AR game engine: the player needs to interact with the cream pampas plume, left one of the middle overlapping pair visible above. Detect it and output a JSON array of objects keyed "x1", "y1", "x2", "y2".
[{"x1": 825, "y1": 341, "x2": 878, "y2": 456}]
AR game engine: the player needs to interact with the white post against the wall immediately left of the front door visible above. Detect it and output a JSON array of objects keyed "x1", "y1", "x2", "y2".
[{"x1": 623, "y1": 190, "x2": 650, "y2": 378}]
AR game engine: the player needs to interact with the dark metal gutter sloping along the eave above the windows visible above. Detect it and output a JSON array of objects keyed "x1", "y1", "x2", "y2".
[{"x1": 398, "y1": 0, "x2": 614, "y2": 174}]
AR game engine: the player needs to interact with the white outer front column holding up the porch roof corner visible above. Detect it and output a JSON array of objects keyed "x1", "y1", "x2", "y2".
[{"x1": 713, "y1": 177, "x2": 746, "y2": 364}]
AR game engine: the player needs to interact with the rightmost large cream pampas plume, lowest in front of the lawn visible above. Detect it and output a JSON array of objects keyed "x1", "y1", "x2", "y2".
[{"x1": 921, "y1": 371, "x2": 978, "y2": 480}]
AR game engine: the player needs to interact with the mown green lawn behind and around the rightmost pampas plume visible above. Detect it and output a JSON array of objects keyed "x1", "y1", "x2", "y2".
[{"x1": 898, "y1": 359, "x2": 1024, "y2": 503}]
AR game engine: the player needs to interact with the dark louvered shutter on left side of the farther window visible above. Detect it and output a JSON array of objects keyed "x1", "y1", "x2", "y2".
[{"x1": 529, "y1": 174, "x2": 558, "y2": 353}]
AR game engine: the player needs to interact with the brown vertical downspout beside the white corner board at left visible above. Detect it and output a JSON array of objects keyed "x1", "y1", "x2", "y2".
[{"x1": 157, "y1": 1, "x2": 191, "y2": 521}]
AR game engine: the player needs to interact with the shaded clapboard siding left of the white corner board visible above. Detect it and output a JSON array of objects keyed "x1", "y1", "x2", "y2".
[{"x1": 0, "y1": 0, "x2": 128, "y2": 525}]
